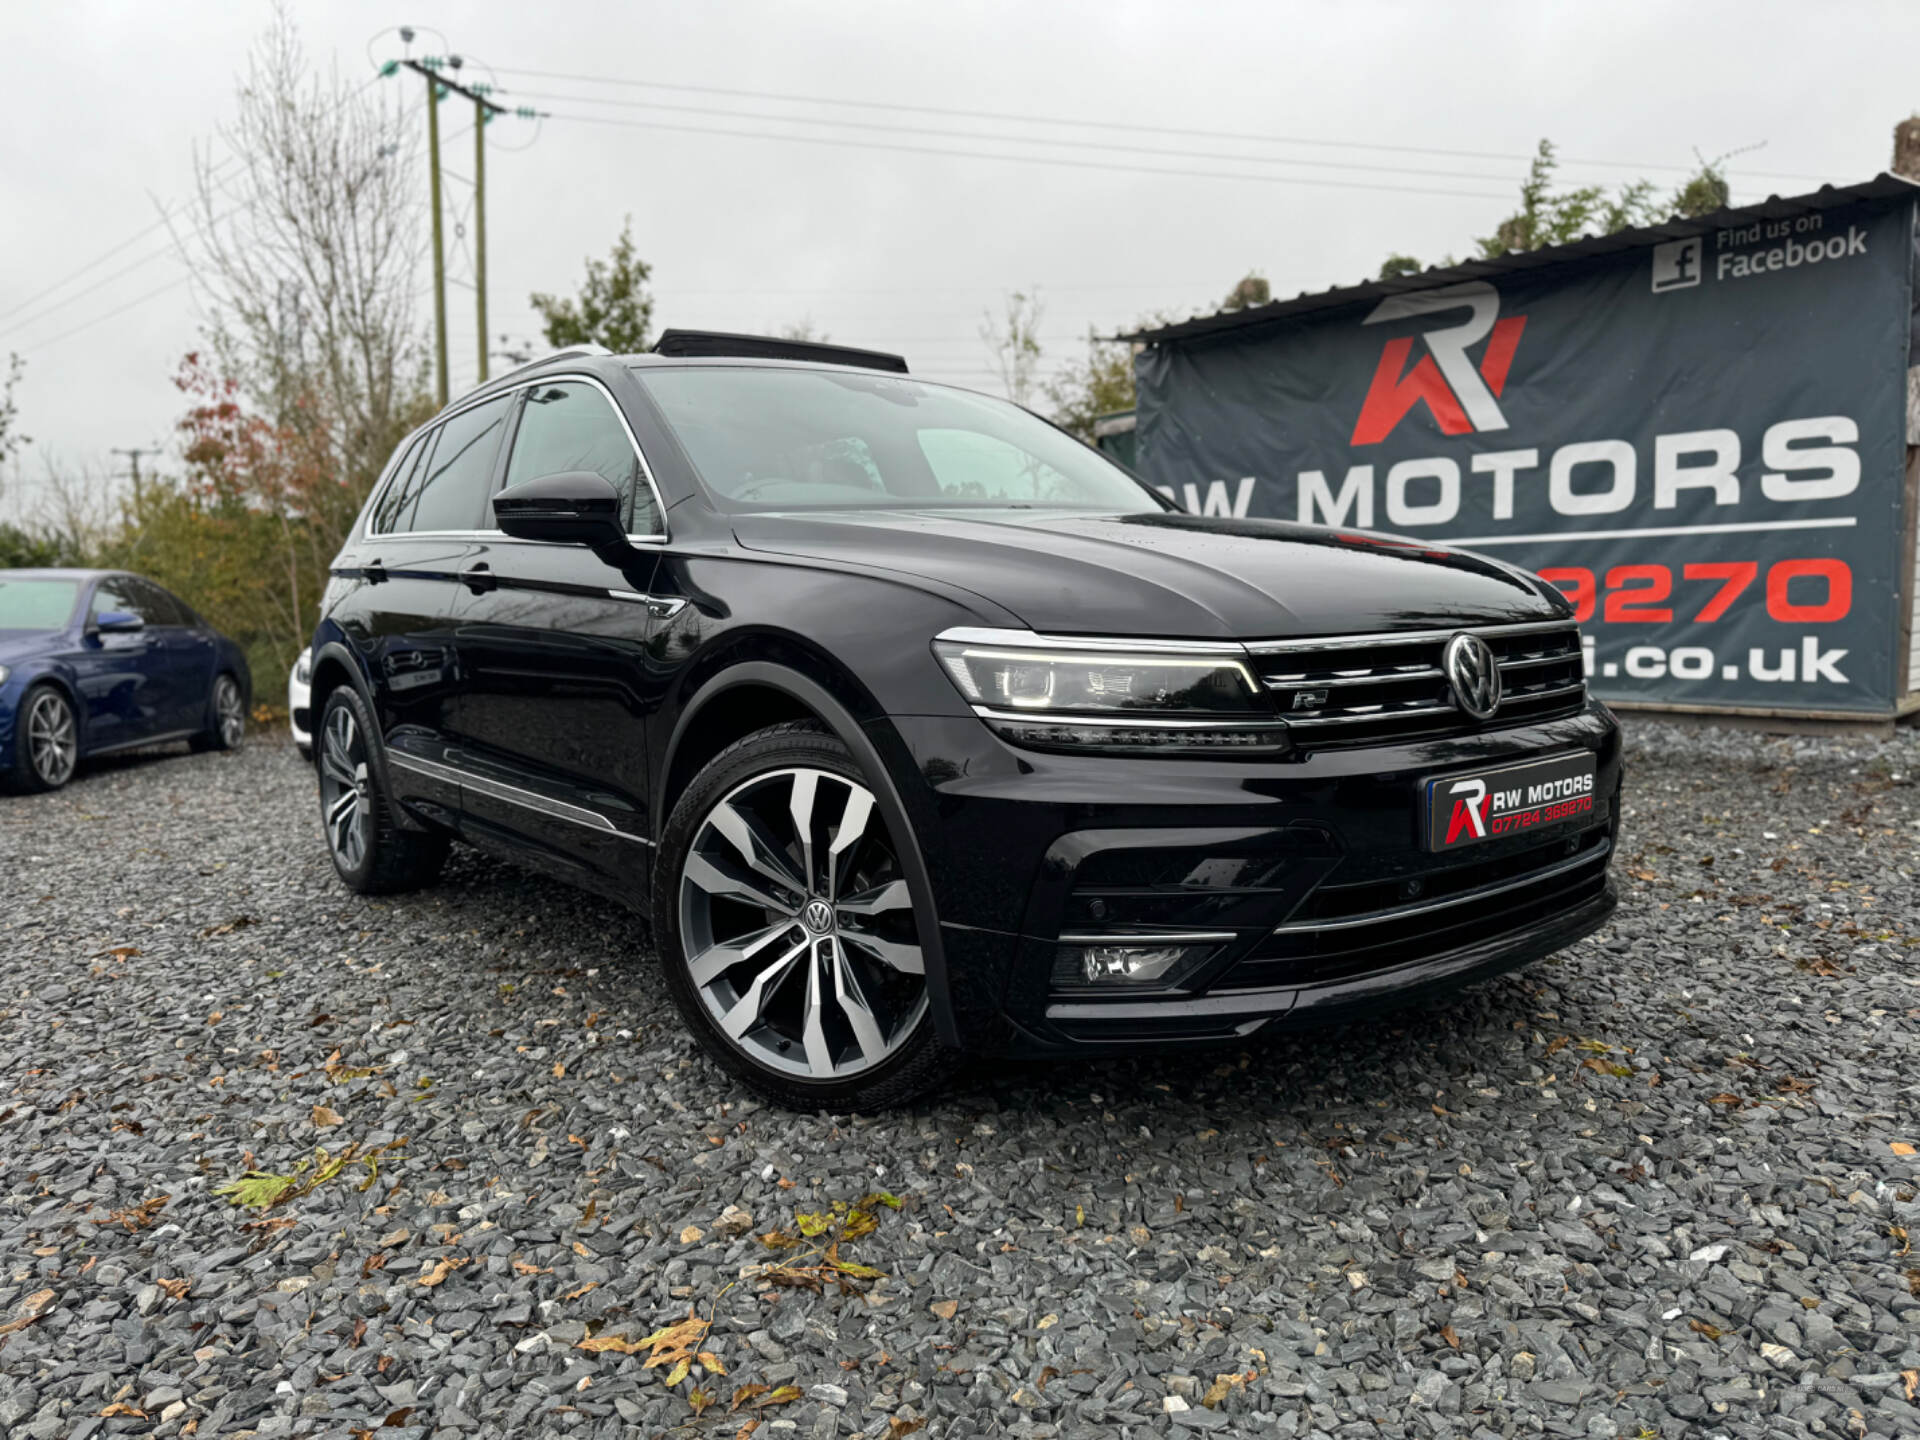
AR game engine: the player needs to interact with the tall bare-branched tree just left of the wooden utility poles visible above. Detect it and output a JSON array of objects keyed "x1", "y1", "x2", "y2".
[{"x1": 180, "y1": 8, "x2": 426, "y2": 507}]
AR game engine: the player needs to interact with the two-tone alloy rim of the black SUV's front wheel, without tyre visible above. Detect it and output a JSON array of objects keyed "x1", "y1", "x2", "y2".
[{"x1": 680, "y1": 768, "x2": 927, "y2": 1081}]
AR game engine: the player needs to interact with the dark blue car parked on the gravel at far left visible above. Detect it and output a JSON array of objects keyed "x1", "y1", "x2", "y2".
[{"x1": 0, "y1": 570, "x2": 252, "y2": 791}]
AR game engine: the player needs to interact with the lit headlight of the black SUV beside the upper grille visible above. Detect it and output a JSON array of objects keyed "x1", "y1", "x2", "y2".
[{"x1": 933, "y1": 632, "x2": 1286, "y2": 751}]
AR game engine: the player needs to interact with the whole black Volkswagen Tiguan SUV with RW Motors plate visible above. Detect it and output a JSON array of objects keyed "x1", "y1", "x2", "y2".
[{"x1": 313, "y1": 332, "x2": 1620, "y2": 1108}]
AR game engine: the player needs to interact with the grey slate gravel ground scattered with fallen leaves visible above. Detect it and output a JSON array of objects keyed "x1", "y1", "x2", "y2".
[{"x1": 0, "y1": 724, "x2": 1920, "y2": 1440}]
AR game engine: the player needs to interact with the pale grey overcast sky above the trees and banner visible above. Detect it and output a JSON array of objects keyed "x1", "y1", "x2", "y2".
[{"x1": 0, "y1": 0, "x2": 1920, "y2": 518}]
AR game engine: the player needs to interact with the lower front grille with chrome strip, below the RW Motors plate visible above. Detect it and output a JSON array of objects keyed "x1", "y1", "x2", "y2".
[{"x1": 1221, "y1": 826, "x2": 1613, "y2": 989}]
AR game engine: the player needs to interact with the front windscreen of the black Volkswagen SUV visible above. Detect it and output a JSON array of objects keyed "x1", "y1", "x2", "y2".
[{"x1": 639, "y1": 365, "x2": 1165, "y2": 513}]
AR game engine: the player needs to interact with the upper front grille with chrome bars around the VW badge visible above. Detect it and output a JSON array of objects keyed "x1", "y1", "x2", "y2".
[{"x1": 1248, "y1": 620, "x2": 1586, "y2": 751}]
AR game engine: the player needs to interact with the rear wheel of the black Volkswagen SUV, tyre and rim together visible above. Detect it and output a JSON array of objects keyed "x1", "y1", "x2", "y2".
[{"x1": 315, "y1": 685, "x2": 449, "y2": 895}]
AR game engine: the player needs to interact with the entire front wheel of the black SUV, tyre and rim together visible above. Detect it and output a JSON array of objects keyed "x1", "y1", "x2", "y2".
[{"x1": 655, "y1": 722, "x2": 958, "y2": 1110}]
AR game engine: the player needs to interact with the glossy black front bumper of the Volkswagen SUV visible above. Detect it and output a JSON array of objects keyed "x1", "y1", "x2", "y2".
[{"x1": 874, "y1": 703, "x2": 1622, "y2": 1054}]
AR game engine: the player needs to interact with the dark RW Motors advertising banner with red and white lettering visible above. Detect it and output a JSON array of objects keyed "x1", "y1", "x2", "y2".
[{"x1": 1137, "y1": 200, "x2": 1914, "y2": 714}]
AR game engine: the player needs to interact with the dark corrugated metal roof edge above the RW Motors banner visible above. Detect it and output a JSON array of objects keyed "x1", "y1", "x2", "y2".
[{"x1": 1119, "y1": 173, "x2": 1920, "y2": 344}]
